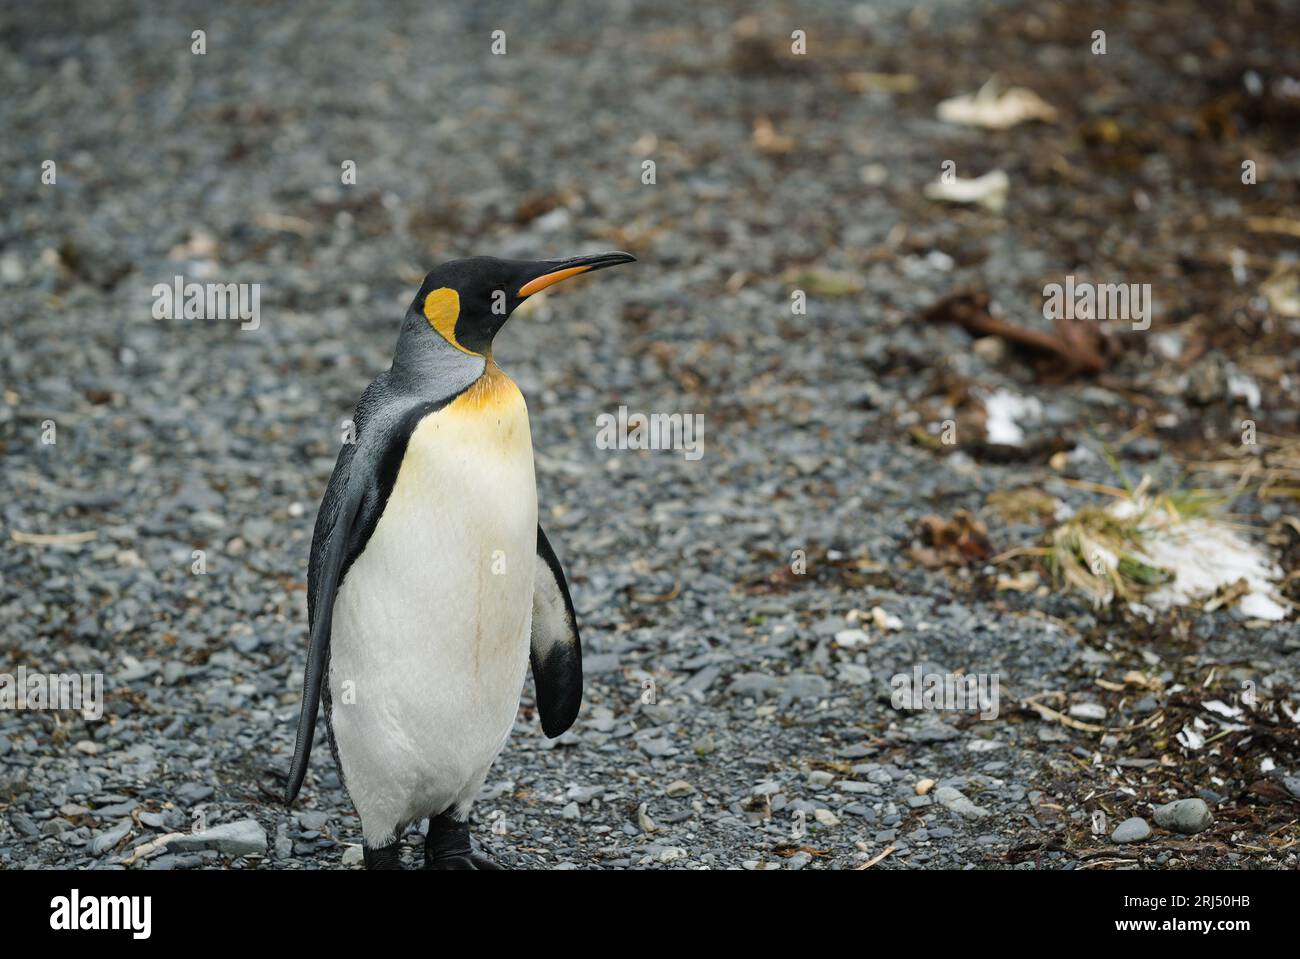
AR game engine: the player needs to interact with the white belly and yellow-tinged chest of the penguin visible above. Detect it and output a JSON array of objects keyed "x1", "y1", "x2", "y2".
[{"x1": 329, "y1": 373, "x2": 537, "y2": 845}]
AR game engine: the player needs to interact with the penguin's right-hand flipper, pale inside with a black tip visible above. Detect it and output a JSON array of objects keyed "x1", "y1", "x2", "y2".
[{"x1": 529, "y1": 526, "x2": 582, "y2": 739}]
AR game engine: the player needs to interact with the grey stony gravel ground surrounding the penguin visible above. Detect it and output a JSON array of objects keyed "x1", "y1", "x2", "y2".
[{"x1": 0, "y1": 3, "x2": 1300, "y2": 869}]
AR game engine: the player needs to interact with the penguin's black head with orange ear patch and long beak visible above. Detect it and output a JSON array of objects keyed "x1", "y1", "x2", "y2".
[{"x1": 411, "y1": 252, "x2": 636, "y2": 356}]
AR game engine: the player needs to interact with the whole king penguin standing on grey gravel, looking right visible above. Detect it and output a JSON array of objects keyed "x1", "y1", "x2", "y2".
[{"x1": 286, "y1": 253, "x2": 634, "y2": 869}]
